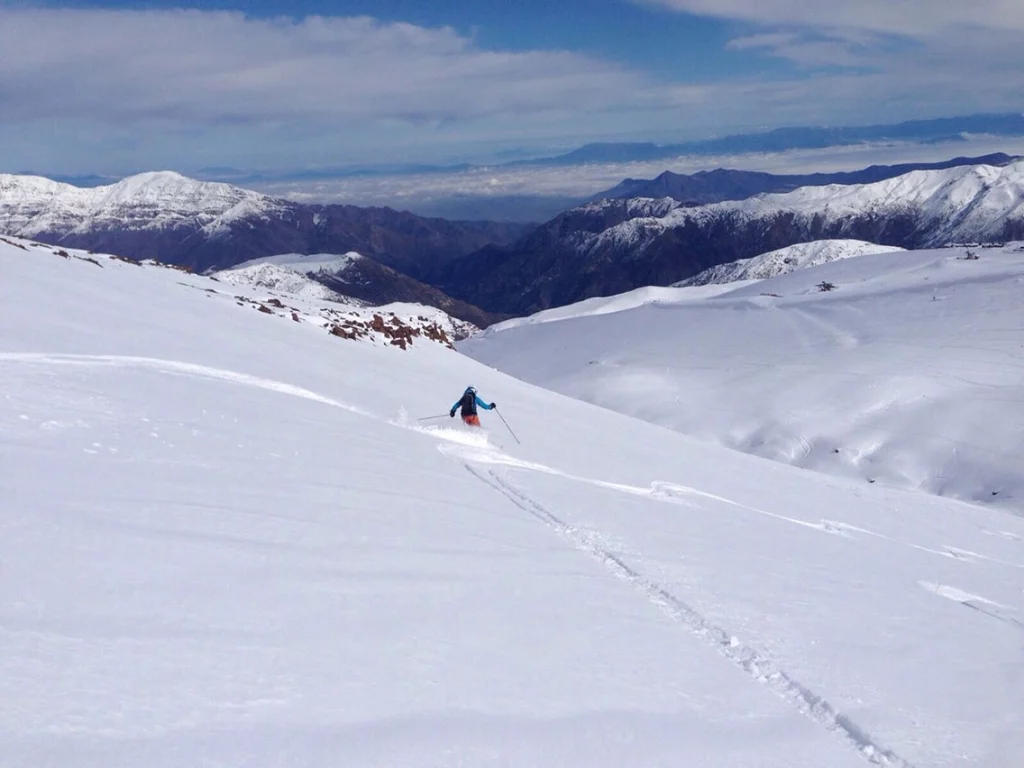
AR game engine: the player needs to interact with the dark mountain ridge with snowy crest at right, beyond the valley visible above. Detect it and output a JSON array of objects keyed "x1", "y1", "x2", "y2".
[{"x1": 440, "y1": 161, "x2": 1024, "y2": 313}]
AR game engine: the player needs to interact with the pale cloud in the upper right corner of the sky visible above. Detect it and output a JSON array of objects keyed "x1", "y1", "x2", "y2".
[{"x1": 633, "y1": 0, "x2": 1024, "y2": 120}]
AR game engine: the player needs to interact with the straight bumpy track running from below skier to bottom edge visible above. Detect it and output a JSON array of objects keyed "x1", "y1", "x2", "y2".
[{"x1": 463, "y1": 462, "x2": 913, "y2": 768}]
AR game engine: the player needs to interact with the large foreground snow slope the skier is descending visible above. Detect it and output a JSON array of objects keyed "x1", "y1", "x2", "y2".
[{"x1": 6, "y1": 237, "x2": 1024, "y2": 768}]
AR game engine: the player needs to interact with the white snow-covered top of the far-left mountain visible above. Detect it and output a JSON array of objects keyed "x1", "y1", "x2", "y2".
[{"x1": 0, "y1": 171, "x2": 285, "y2": 238}]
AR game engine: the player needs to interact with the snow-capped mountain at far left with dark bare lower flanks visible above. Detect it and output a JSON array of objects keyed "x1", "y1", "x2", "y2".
[{"x1": 0, "y1": 171, "x2": 523, "y2": 279}]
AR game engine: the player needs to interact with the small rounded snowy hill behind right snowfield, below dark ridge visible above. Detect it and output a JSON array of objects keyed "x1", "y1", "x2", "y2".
[{"x1": 677, "y1": 240, "x2": 904, "y2": 288}]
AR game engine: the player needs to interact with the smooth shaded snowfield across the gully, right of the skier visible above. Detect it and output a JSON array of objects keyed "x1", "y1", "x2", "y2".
[{"x1": 463, "y1": 246, "x2": 1024, "y2": 511}]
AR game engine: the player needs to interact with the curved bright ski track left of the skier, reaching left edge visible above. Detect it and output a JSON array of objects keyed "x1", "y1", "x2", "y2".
[{"x1": 0, "y1": 352, "x2": 370, "y2": 416}]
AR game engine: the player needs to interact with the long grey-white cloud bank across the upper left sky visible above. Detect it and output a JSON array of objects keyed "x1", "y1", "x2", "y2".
[{"x1": 0, "y1": 9, "x2": 700, "y2": 126}]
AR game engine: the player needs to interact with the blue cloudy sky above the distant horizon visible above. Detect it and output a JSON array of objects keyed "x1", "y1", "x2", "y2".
[{"x1": 0, "y1": 0, "x2": 1024, "y2": 173}]
